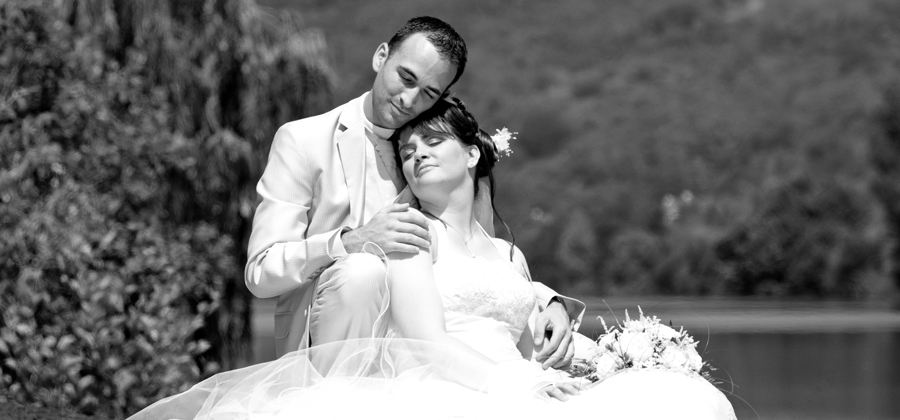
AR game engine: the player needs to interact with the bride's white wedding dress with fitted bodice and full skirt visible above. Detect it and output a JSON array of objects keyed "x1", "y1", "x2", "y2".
[{"x1": 134, "y1": 221, "x2": 735, "y2": 420}]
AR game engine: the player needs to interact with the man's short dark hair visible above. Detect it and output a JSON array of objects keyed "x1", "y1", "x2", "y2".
[{"x1": 388, "y1": 16, "x2": 469, "y2": 87}]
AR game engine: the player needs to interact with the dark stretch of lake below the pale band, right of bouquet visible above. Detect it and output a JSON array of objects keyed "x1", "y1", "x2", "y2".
[{"x1": 698, "y1": 331, "x2": 900, "y2": 419}]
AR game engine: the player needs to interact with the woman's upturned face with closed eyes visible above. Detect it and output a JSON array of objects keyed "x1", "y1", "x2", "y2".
[{"x1": 398, "y1": 129, "x2": 480, "y2": 200}]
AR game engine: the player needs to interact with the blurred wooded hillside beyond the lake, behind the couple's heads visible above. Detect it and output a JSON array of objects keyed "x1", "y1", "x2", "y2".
[{"x1": 262, "y1": 0, "x2": 900, "y2": 297}]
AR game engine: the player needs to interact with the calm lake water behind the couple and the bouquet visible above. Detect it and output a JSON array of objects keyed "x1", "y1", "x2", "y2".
[{"x1": 254, "y1": 297, "x2": 900, "y2": 420}]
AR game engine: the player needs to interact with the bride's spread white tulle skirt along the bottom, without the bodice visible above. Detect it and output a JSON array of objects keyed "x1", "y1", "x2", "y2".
[{"x1": 132, "y1": 338, "x2": 734, "y2": 420}]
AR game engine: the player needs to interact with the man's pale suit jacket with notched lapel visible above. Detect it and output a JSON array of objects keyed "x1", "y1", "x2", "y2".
[{"x1": 244, "y1": 94, "x2": 583, "y2": 357}]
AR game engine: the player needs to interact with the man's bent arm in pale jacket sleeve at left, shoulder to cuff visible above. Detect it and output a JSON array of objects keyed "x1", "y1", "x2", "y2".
[{"x1": 244, "y1": 123, "x2": 341, "y2": 298}]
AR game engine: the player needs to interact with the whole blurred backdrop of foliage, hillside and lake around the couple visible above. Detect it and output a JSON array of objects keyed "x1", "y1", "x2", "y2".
[{"x1": 0, "y1": 0, "x2": 900, "y2": 419}]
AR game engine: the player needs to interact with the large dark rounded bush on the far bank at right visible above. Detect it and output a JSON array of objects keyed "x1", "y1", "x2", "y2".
[{"x1": 717, "y1": 178, "x2": 888, "y2": 297}]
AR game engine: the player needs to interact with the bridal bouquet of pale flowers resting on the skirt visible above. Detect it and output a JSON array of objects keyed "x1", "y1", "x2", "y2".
[{"x1": 571, "y1": 307, "x2": 714, "y2": 382}]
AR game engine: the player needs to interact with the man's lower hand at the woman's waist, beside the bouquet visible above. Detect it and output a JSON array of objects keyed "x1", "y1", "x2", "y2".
[{"x1": 534, "y1": 302, "x2": 575, "y2": 369}]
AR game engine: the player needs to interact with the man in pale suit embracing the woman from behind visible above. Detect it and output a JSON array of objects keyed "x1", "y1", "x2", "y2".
[{"x1": 244, "y1": 17, "x2": 584, "y2": 367}]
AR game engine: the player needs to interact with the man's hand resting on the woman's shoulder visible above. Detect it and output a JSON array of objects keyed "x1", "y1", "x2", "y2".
[{"x1": 341, "y1": 203, "x2": 431, "y2": 254}]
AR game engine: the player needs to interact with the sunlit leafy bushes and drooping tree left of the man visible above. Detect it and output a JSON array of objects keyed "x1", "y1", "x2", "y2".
[{"x1": 0, "y1": 0, "x2": 329, "y2": 417}]
